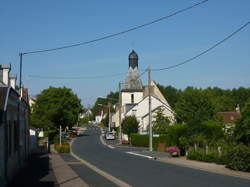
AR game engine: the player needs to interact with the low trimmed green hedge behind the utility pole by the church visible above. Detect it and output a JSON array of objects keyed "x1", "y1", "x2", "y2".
[{"x1": 131, "y1": 133, "x2": 167, "y2": 149}]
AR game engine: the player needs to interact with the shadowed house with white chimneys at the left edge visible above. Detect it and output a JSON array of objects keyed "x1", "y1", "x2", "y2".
[{"x1": 0, "y1": 65, "x2": 29, "y2": 186}]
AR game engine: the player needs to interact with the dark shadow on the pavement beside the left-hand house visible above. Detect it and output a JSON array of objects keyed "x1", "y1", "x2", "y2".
[{"x1": 9, "y1": 154, "x2": 59, "y2": 187}]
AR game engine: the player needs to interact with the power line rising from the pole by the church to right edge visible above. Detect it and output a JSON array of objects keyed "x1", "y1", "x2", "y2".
[{"x1": 152, "y1": 21, "x2": 250, "y2": 71}]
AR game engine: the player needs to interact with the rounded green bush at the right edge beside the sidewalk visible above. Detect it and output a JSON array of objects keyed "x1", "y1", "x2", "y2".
[{"x1": 227, "y1": 145, "x2": 250, "y2": 171}]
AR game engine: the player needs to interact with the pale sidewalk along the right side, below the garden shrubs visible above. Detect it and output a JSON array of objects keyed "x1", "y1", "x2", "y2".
[{"x1": 157, "y1": 157, "x2": 250, "y2": 180}]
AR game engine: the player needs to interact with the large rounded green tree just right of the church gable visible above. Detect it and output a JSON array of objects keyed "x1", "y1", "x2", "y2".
[{"x1": 175, "y1": 87, "x2": 214, "y2": 127}]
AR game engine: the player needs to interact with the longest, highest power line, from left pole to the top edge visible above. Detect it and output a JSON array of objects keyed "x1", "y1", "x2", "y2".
[{"x1": 22, "y1": 0, "x2": 208, "y2": 55}]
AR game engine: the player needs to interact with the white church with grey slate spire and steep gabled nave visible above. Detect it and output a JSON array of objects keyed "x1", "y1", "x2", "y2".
[{"x1": 112, "y1": 50, "x2": 175, "y2": 133}]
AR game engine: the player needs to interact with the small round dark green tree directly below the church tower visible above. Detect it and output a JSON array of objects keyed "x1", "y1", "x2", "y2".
[{"x1": 122, "y1": 116, "x2": 139, "y2": 140}]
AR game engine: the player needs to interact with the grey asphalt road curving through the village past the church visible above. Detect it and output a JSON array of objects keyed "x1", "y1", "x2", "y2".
[{"x1": 72, "y1": 125, "x2": 250, "y2": 187}]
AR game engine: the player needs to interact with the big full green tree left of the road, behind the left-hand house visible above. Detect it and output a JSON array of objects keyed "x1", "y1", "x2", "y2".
[{"x1": 31, "y1": 87, "x2": 82, "y2": 129}]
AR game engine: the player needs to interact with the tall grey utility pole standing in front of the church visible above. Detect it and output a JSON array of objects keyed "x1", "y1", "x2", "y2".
[{"x1": 148, "y1": 66, "x2": 153, "y2": 151}]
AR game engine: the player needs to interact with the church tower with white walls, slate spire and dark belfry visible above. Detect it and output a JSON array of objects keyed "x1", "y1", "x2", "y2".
[{"x1": 122, "y1": 50, "x2": 143, "y2": 110}]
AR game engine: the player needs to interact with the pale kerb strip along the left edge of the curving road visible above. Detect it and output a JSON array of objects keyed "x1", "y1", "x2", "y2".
[{"x1": 70, "y1": 140, "x2": 131, "y2": 187}]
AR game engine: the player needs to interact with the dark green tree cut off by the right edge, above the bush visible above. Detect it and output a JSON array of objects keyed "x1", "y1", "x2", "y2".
[{"x1": 234, "y1": 100, "x2": 250, "y2": 145}]
